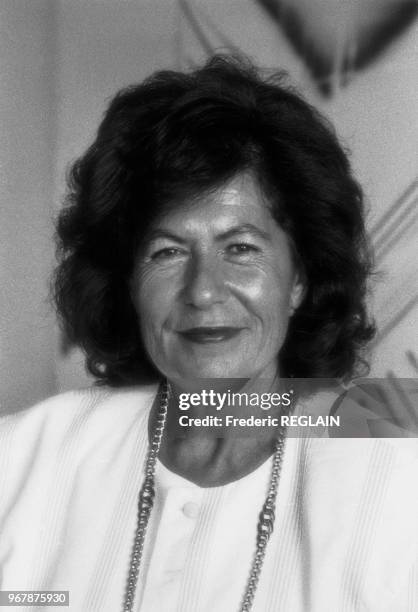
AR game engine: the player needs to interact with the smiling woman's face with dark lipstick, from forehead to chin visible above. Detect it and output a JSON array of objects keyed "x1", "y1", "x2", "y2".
[{"x1": 131, "y1": 174, "x2": 303, "y2": 380}]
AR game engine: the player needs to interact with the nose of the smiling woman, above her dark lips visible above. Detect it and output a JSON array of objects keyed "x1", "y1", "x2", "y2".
[{"x1": 184, "y1": 257, "x2": 228, "y2": 309}]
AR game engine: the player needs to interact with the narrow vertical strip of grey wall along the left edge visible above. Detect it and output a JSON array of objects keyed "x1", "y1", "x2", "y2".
[{"x1": 0, "y1": 0, "x2": 57, "y2": 410}]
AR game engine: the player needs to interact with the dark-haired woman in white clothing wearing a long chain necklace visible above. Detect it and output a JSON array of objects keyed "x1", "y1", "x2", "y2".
[{"x1": 0, "y1": 57, "x2": 417, "y2": 612}]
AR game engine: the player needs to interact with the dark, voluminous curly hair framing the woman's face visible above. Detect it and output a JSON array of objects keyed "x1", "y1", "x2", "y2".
[{"x1": 53, "y1": 56, "x2": 374, "y2": 386}]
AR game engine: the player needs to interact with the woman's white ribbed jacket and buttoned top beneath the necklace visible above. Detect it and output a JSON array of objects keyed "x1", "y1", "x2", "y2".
[{"x1": 0, "y1": 386, "x2": 418, "y2": 612}]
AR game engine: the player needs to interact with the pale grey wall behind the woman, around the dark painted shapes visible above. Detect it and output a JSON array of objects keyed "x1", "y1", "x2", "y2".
[{"x1": 0, "y1": 0, "x2": 418, "y2": 411}]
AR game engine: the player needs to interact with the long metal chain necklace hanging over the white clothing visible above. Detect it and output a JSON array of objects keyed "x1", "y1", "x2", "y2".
[{"x1": 123, "y1": 382, "x2": 286, "y2": 612}]
